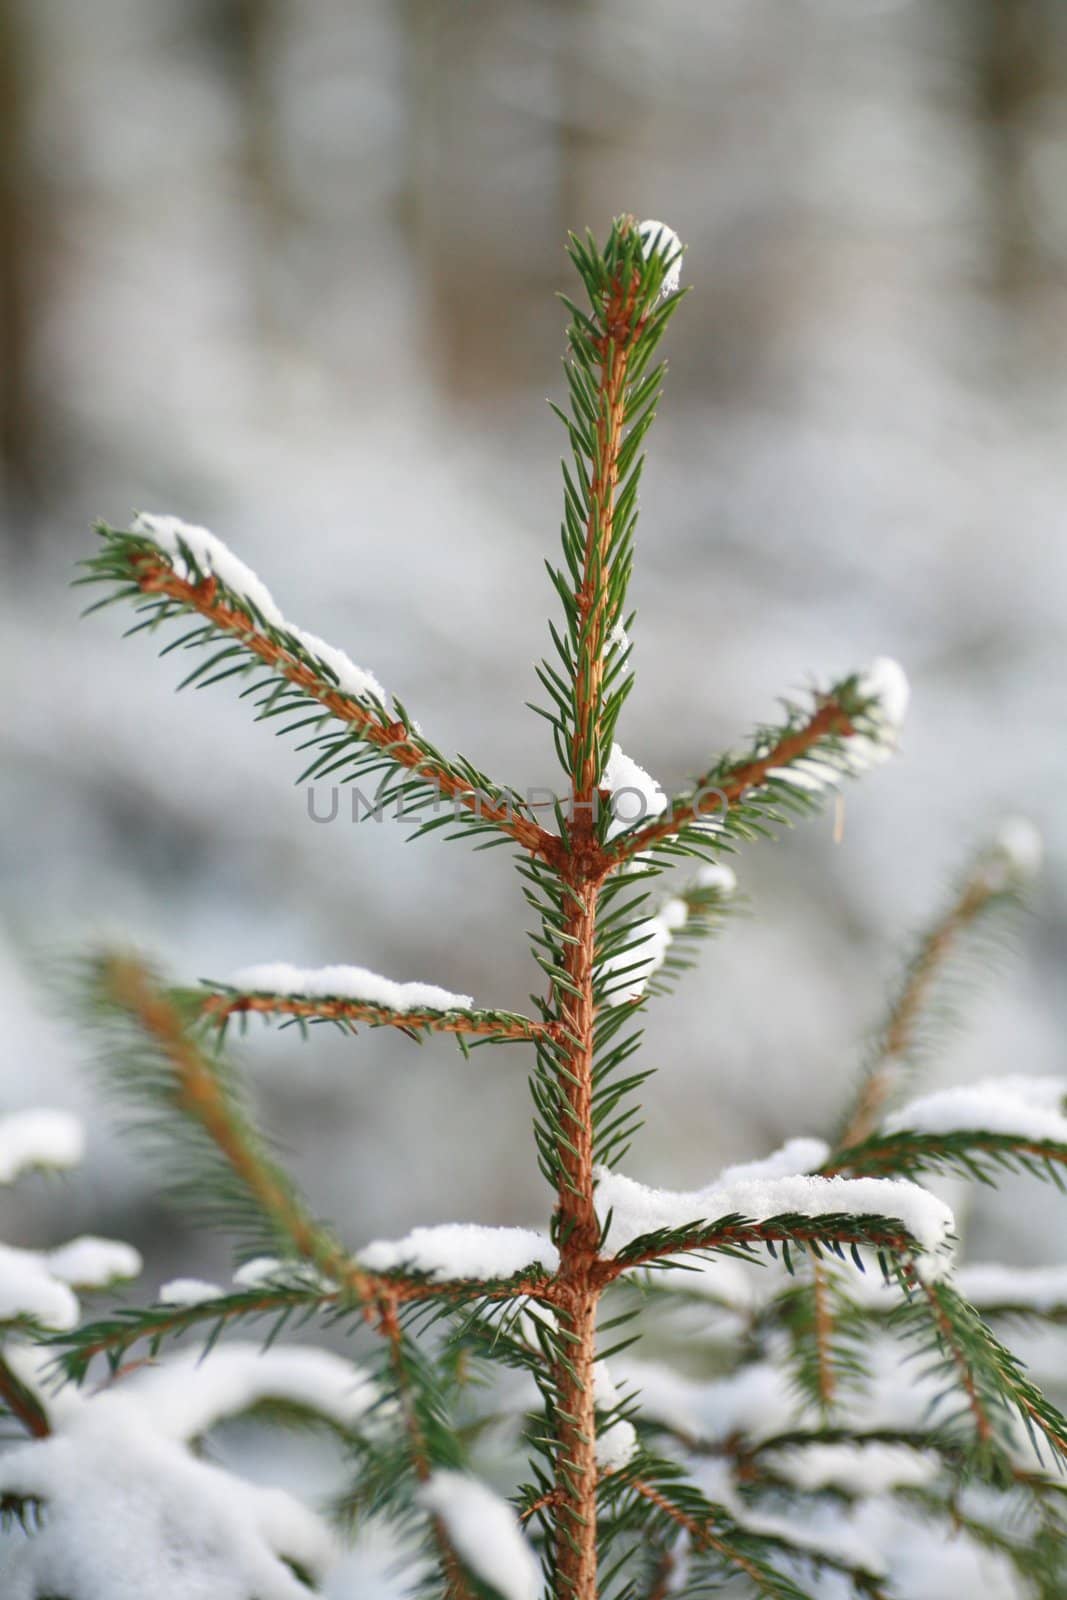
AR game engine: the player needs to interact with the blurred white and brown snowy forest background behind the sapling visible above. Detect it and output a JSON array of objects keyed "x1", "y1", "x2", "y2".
[{"x1": 0, "y1": 0, "x2": 1067, "y2": 1296}]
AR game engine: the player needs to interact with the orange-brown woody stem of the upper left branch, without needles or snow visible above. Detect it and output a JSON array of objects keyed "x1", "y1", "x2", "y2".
[{"x1": 119, "y1": 547, "x2": 555, "y2": 856}]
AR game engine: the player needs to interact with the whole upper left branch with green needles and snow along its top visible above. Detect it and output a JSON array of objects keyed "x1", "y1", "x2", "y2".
[{"x1": 82, "y1": 514, "x2": 552, "y2": 854}]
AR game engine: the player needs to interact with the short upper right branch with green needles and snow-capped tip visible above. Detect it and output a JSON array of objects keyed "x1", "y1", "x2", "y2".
[{"x1": 608, "y1": 656, "x2": 909, "y2": 862}]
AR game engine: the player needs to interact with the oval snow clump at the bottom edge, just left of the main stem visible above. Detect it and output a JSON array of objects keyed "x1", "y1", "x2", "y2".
[{"x1": 419, "y1": 1472, "x2": 541, "y2": 1600}]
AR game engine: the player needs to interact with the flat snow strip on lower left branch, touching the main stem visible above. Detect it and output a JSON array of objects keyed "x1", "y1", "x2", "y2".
[{"x1": 357, "y1": 1222, "x2": 560, "y2": 1283}]
